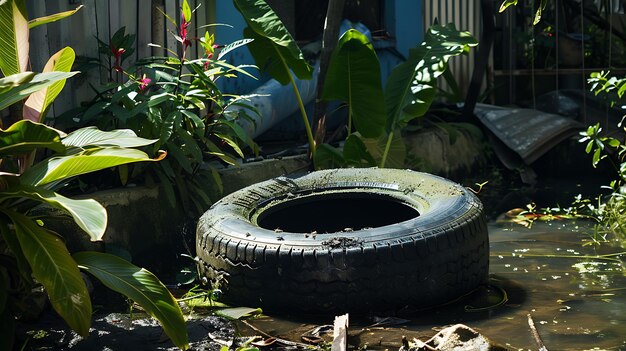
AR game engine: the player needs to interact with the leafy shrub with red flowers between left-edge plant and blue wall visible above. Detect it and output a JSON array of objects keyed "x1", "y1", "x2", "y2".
[{"x1": 57, "y1": 1, "x2": 257, "y2": 214}]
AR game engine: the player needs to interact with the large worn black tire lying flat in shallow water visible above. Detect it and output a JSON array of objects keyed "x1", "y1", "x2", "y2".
[{"x1": 197, "y1": 169, "x2": 489, "y2": 313}]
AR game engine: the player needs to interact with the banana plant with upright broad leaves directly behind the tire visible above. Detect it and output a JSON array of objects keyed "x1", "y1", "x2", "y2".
[{"x1": 315, "y1": 24, "x2": 478, "y2": 168}]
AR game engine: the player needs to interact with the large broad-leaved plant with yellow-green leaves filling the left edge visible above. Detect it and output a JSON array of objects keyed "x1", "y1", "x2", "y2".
[{"x1": 0, "y1": 0, "x2": 188, "y2": 350}]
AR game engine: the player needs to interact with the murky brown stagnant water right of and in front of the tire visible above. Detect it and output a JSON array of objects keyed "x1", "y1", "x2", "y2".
[{"x1": 242, "y1": 220, "x2": 626, "y2": 350}]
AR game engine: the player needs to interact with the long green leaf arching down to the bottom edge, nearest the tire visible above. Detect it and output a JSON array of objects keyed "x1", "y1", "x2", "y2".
[{"x1": 74, "y1": 252, "x2": 189, "y2": 350}]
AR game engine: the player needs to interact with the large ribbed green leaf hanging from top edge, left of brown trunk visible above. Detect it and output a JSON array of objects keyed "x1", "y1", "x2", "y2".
[{"x1": 234, "y1": 0, "x2": 313, "y2": 85}]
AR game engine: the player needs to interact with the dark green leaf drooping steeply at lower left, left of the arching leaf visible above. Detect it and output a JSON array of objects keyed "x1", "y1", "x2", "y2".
[{"x1": 2, "y1": 209, "x2": 91, "y2": 336}]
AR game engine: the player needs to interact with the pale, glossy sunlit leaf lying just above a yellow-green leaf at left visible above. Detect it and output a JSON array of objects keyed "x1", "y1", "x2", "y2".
[{"x1": 62, "y1": 127, "x2": 157, "y2": 148}]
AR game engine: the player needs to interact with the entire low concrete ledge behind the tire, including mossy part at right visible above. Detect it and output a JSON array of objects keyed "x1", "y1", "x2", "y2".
[{"x1": 47, "y1": 129, "x2": 484, "y2": 271}]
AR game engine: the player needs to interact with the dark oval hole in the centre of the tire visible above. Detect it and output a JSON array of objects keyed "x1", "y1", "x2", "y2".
[{"x1": 257, "y1": 193, "x2": 419, "y2": 234}]
